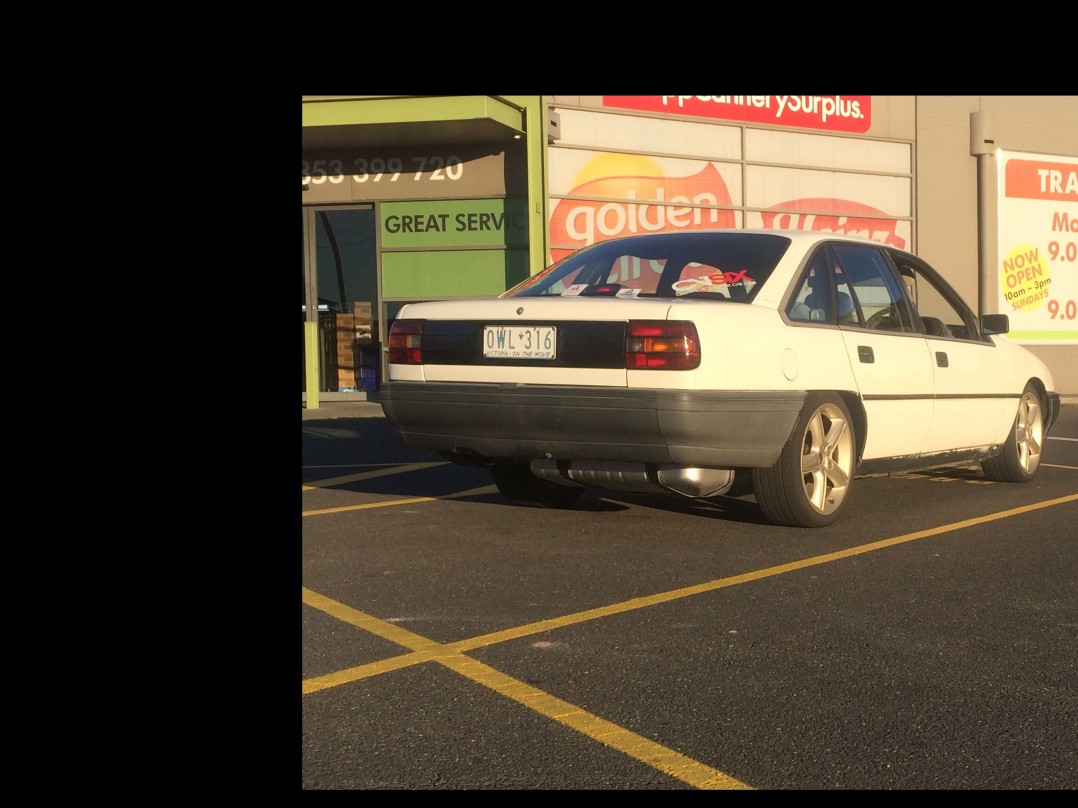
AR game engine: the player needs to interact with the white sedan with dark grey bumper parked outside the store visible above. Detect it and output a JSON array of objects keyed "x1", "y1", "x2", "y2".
[{"x1": 379, "y1": 229, "x2": 1060, "y2": 527}]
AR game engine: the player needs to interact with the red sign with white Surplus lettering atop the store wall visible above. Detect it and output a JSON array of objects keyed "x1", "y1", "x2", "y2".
[{"x1": 603, "y1": 96, "x2": 872, "y2": 133}]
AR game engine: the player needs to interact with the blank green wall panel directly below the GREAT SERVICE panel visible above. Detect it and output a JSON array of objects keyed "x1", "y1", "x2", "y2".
[{"x1": 382, "y1": 249, "x2": 528, "y2": 298}]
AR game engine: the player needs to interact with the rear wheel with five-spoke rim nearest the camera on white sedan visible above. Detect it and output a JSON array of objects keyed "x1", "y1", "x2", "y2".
[{"x1": 752, "y1": 393, "x2": 857, "y2": 528}]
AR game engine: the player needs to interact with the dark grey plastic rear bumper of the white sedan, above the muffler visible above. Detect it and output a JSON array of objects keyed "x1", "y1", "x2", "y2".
[{"x1": 378, "y1": 381, "x2": 805, "y2": 468}]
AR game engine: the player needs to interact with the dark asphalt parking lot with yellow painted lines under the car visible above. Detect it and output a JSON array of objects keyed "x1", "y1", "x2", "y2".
[{"x1": 295, "y1": 404, "x2": 1078, "y2": 791}]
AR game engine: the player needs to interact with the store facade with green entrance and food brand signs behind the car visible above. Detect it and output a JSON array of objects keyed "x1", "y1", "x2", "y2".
[{"x1": 302, "y1": 96, "x2": 1078, "y2": 407}]
